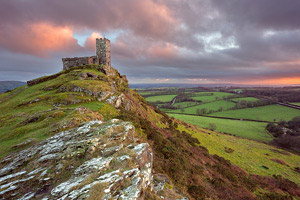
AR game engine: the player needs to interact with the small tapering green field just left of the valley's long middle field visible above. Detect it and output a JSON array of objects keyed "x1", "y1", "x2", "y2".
[{"x1": 170, "y1": 100, "x2": 235, "y2": 115}]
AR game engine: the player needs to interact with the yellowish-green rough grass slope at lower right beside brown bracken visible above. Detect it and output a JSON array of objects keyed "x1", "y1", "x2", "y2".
[{"x1": 178, "y1": 126, "x2": 300, "y2": 185}]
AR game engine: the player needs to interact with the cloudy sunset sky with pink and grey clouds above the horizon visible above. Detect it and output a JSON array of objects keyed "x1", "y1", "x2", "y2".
[{"x1": 0, "y1": 0, "x2": 300, "y2": 85}]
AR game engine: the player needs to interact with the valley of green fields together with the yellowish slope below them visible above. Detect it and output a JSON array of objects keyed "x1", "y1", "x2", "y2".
[{"x1": 137, "y1": 85, "x2": 300, "y2": 184}]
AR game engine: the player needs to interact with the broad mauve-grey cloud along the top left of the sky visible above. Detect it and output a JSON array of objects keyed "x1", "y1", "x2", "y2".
[{"x1": 0, "y1": 0, "x2": 176, "y2": 38}]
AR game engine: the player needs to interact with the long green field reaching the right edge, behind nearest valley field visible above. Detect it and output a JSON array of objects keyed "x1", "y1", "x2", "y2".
[{"x1": 210, "y1": 105, "x2": 300, "y2": 121}]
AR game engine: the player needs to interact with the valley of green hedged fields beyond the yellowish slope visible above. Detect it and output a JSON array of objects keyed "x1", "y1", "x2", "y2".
[{"x1": 138, "y1": 87, "x2": 300, "y2": 142}]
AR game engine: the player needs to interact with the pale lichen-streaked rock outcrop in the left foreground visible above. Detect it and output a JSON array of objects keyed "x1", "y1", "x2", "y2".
[{"x1": 0, "y1": 119, "x2": 153, "y2": 200}]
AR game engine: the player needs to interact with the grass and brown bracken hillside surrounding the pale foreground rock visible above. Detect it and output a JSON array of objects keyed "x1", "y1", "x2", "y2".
[{"x1": 0, "y1": 65, "x2": 300, "y2": 199}]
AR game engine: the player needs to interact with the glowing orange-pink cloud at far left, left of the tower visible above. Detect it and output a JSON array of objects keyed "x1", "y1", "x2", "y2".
[{"x1": 0, "y1": 23, "x2": 79, "y2": 57}]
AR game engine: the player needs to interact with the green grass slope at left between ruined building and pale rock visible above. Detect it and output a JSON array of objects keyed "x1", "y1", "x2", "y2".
[{"x1": 0, "y1": 68, "x2": 118, "y2": 158}]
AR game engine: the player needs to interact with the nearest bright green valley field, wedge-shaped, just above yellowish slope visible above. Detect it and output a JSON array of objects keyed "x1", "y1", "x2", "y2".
[{"x1": 168, "y1": 113, "x2": 273, "y2": 142}]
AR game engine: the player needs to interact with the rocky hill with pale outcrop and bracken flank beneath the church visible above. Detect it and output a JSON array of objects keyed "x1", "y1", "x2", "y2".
[{"x1": 0, "y1": 65, "x2": 300, "y2": 199}]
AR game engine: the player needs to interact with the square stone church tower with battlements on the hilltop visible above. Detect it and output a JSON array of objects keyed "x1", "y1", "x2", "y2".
[{"x1": 96, "y1": 38, "x2": 111, "y2": 67}]
